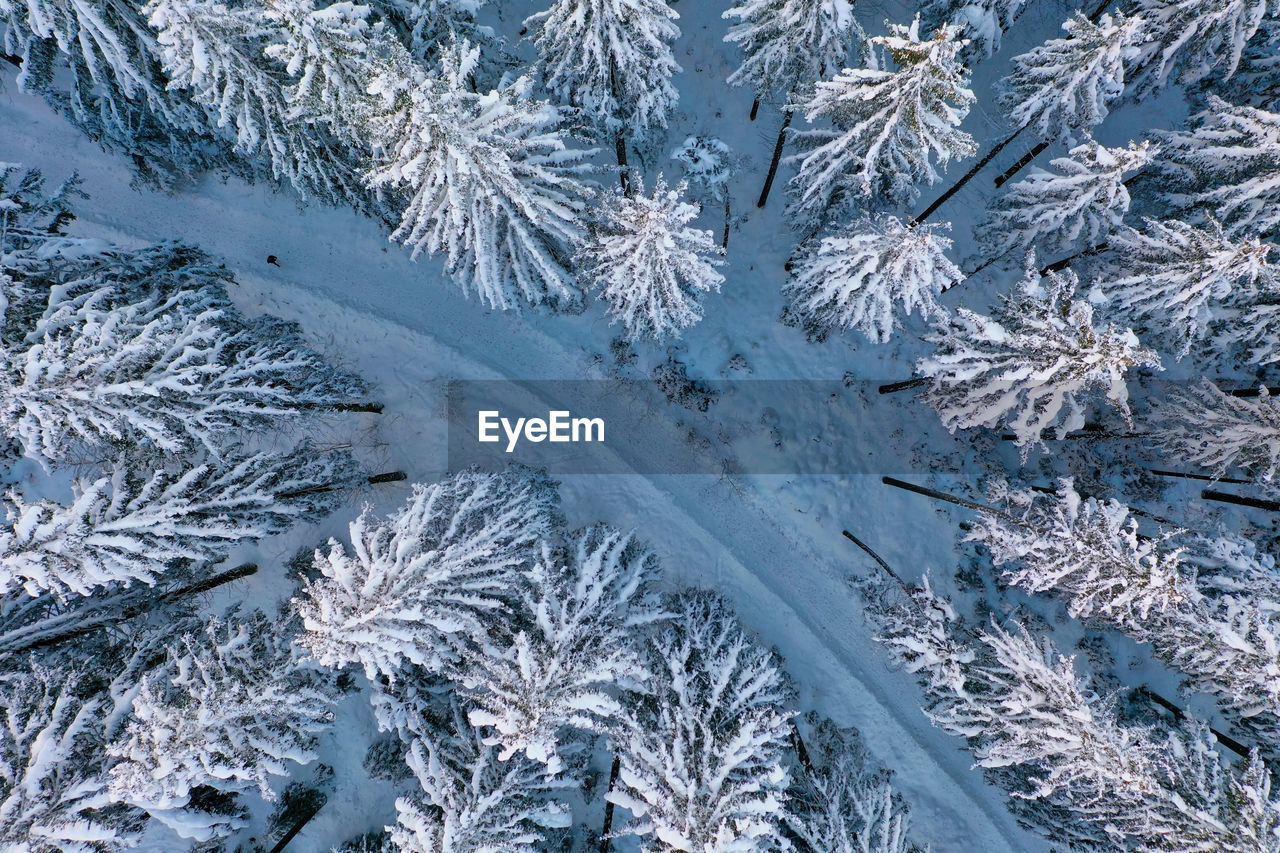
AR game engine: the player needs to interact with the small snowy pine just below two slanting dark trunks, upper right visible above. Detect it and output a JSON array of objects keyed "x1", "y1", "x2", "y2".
[{"x1": 978, "y1": 141, "x2": 1156, "y2": 257}]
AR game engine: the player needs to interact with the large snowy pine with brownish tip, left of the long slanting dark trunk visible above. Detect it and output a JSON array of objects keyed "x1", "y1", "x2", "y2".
[{"x1": 788, "y1": 18, "x2": 977, "y2": 224}]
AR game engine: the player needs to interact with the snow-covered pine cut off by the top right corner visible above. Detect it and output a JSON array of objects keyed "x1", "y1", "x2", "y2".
[{"x1": 1132, "y1": 0, "x2": 1280, "y2": 96}]
